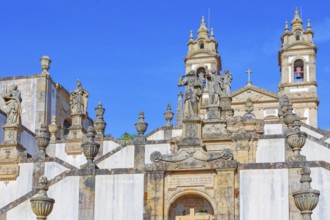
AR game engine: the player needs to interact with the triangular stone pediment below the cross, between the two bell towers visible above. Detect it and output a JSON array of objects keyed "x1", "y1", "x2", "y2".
[{"x1": 232, "y1": 85, "x2": 279, "y2": 103}]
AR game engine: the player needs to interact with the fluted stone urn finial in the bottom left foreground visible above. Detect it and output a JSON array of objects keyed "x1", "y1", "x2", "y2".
[{"x1": 30, "y1": 176, "x2": 55, "y2": 220}]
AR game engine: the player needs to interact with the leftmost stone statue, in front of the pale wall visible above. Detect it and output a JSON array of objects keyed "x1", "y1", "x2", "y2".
[{"x1": 2, "y1": 84, "x2": 22, "y2": 125}]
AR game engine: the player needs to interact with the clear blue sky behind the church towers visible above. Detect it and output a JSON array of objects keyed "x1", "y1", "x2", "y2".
[{"x1": 0, "y1": 0, "x2": 330, "y2": 137}]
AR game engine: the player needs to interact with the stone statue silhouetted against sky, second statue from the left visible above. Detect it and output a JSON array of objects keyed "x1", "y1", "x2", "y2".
[{"x1": 70, "y1": 80, "x2": 88, "y2": 115}]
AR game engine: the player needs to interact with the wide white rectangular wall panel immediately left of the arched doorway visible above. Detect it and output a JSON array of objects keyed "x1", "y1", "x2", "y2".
[{"x1": 94, "y1": 174, "x2": 144, "y2": 220}]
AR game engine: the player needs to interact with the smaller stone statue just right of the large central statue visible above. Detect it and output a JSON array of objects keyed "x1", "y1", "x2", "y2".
[{"x1": 207, "y1": 71, "x2": 223, "y2": 105}]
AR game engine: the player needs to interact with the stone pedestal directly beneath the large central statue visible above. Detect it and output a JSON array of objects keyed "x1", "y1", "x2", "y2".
[{"x1": 178, "y1": 117, "x2": 202, "y2": 148}]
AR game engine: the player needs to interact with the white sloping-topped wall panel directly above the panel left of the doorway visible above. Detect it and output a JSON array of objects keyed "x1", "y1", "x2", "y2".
[{"x1": 97, "y1": 145, "x2": 134, "y2": 169}]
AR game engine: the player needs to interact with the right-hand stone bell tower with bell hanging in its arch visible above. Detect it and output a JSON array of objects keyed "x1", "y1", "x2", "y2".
[{"x1": 278, "y1": 8, "x2": 319, "y2": 127}]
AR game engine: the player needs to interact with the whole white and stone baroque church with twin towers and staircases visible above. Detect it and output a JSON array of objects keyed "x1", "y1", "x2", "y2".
[{"x1": 0, "y1": 9, "x2": 330, "y2": 220}]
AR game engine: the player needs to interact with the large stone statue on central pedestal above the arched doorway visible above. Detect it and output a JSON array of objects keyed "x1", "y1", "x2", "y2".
[{"x1": 178, "y1": 70, "x2": 203, "y2": 118}]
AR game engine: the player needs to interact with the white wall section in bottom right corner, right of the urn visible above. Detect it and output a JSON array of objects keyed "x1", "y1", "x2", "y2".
[{"x1": 311, "y1": 168, "x2": 330, "y2": 220}]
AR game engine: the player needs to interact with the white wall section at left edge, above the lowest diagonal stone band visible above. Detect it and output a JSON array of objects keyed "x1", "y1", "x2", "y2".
[{"x1": 0, "y1": 163, "x2": 33, "y2": 208}]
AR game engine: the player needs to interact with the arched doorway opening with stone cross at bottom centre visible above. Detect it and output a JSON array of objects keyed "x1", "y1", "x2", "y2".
[{"x1": 168, "y1": 194, "x2": 215, "y2": 220}]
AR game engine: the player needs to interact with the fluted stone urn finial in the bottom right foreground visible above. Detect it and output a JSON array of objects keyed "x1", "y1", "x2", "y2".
[{"x1": 292, "y1": 167, "x2": 320, "y2": 220}]
